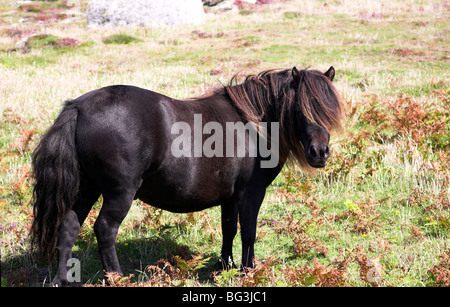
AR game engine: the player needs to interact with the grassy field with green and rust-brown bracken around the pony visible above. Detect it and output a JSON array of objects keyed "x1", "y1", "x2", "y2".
[{"x1": 0, "y1": 0, "x2": 450, "y2": 287}]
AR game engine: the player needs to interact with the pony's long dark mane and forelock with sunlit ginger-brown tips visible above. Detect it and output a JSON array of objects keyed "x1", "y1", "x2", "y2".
[{"x1": 224, "y1": 69, "x2": 344, "y2": 170}]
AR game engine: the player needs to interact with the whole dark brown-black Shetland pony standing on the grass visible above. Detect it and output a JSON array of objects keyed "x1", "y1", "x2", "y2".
[{"x1": 31, "y1": 67, "x2": 343, "y2": 285}]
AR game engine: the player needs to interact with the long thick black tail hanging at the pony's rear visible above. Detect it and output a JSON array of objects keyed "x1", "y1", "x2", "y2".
[{"x1": 31, "y1": 101, "x2": 80, "y2": 262}]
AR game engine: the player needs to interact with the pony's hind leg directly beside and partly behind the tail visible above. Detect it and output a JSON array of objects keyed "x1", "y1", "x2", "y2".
[{"x1": 52, "y1": 180, "x2": 100, "y2": 286}]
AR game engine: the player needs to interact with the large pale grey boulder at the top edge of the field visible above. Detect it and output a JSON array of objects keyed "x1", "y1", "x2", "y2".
[{"x1": 86, "y1": 0, "x2": 204, "y2": 28}]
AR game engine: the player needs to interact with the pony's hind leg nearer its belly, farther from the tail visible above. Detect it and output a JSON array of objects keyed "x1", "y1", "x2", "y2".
[{"x1": 94, "y1": 188, "x2": 136, "y2": 275}]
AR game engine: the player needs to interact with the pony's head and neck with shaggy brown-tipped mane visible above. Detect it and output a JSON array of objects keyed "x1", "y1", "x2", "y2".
[{"x1": 224, "y1": 67, "x2": 343, "y2": 170}]
